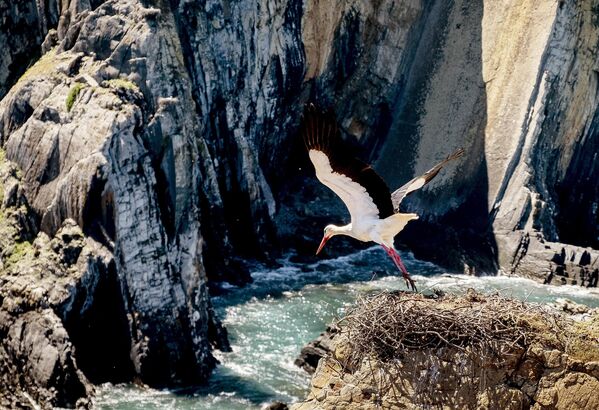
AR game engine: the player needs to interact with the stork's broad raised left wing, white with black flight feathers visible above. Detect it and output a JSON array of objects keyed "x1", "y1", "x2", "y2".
[{"x1": 301, "y1": 104, "x2": 393, "y2": 223}]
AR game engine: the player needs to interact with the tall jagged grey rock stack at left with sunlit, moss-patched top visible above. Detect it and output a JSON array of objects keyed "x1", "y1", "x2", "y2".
[{"x1": 0, "y1": 1, "x2": 227, "y2": 398}]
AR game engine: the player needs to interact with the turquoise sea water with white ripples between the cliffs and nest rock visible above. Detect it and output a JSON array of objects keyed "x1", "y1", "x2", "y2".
[{"x1": 95, "y1": 248, "x2": 599, "y2": 410}]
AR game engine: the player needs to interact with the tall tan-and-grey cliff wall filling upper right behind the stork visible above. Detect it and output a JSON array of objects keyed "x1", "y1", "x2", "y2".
[{"x1": 283, "y1": 1, "x2": 599, "y2": 280}]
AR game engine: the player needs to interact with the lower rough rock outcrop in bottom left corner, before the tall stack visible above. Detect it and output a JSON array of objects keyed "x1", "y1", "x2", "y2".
[{"x1": 0, "y1": 151, "x2": 112, "y2": 408}]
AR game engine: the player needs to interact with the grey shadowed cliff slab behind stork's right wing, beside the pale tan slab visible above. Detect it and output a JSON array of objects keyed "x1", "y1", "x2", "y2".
[{"x1": 375, "y1": 0, "x2": 497, "y2": 273}]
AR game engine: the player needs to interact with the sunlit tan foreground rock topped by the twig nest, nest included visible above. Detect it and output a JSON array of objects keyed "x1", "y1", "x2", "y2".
[{"x1": 291, "y1": 293, "x2": 599, "y2": 410}]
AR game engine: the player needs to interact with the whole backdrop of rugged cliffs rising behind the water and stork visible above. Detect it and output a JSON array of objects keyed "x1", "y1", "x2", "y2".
[{"x1": 0, "y1": 0, "x2": 599, "y2": 406}]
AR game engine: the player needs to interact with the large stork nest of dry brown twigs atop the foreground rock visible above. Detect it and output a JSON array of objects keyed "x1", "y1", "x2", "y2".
[{"x1": 340, "y1": 291, "x2": 557, "y2": 365}]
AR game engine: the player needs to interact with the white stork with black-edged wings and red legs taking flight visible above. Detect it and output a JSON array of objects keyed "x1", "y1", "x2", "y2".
[{"x1": 301, "y1": 104, "x2": 464, "y2": 290}]
